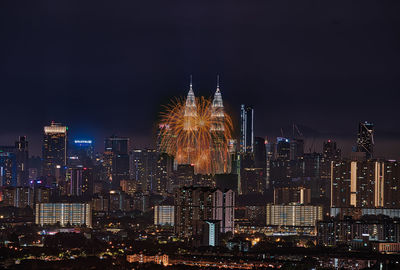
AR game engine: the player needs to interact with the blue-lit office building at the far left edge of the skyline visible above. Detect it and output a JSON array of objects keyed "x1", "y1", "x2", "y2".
[{"x1": 0, "y1": 151, "x2": 17, "y2": 187}]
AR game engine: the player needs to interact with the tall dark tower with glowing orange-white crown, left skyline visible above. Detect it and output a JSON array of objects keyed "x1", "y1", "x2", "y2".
[{"x1": 42, "y1": 122, "x2": 68, "y2": 184}]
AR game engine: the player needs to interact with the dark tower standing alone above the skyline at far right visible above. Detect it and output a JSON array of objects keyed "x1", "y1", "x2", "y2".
[{"x1": 357, "y1": 121, "x2": 374, "y2": 159}]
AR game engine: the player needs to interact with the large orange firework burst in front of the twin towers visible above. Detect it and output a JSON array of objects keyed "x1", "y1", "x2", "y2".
[{"x1": 160, "y1": 95, "x2": 232, "y2": 174}]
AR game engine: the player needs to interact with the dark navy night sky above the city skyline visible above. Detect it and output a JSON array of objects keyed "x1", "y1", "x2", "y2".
[{"x1": 0, "y1": 0, "x2": 400, "y2": 158}]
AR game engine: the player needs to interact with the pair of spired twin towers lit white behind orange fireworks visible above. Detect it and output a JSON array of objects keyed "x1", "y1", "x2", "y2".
[{"x1": 178, "y1": 77, "x2": 231, "y2": 174}]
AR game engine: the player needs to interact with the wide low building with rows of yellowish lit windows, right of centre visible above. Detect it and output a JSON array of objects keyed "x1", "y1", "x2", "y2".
[{"x1": 266, "y1": 204, "x2": 323, "y2": 227}]
